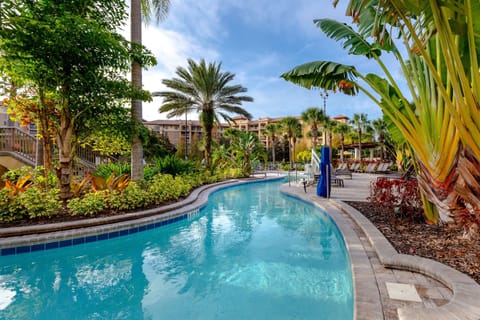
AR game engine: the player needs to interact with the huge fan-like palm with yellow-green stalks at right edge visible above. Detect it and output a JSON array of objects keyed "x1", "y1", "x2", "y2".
[{"x1": 282, "y1": 0, "x2": 480, "y2": 230}]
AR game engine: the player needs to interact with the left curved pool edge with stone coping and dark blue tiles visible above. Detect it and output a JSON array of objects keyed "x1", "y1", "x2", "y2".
[{"x1": 0, "y1": 177, "x2": 283, "y2": 256}]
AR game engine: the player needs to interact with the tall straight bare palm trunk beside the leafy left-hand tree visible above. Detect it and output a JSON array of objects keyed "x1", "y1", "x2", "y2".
[{"x1": 130, "y1": 0, "x2": 143, "y2": 181}]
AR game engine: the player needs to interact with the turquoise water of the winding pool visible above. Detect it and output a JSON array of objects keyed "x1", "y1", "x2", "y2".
[{"x1": 0, "y1": 182, "x2": 353, "y2": 320}]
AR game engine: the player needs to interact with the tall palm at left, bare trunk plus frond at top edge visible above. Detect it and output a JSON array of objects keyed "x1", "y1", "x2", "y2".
[{"x1": 130, "y1": 0, "x2": 170, "y2": 181}]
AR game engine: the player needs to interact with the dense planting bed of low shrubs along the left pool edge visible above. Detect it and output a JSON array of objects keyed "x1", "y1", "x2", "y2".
[{"x1": 0, "y1": 156, "x2": 246, "y2": 224}]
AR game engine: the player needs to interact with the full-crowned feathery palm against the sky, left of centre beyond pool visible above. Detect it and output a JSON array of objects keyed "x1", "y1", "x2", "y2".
[{"x1": 159, "y1": 59, "x2": 253, "y2": 168}]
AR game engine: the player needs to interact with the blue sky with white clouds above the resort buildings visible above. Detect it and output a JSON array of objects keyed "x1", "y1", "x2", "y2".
[{"x1": 136, "y1": 0, "x2": 394, "y2": 120}]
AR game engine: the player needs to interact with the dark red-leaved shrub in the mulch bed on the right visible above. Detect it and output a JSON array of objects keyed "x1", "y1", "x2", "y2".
[{"x1": 368, "y1": 178, "x2": 424, "y2": 221}]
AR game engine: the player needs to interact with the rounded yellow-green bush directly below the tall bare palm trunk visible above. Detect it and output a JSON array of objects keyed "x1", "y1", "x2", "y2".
[{"x1": 108, "y1": 182, "x2": 151, "y2": 211}]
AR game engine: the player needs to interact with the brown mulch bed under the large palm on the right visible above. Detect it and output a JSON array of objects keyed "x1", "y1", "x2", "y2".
[{"x1": 347, "y1": 201, "x2": 480, "y2": 284}]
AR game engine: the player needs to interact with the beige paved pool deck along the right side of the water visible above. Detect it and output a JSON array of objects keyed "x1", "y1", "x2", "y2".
[{"x1": 281, "y1": 173, "x2": 480, "y2": 320}]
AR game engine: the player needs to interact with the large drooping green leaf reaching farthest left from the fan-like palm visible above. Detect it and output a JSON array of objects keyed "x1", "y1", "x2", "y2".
[{"x1": 281, "y1": 61, "x2": 358, "y2": 95}]
